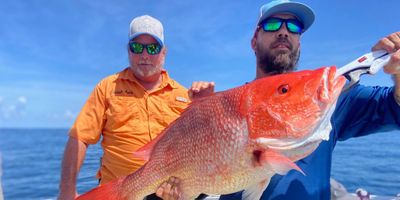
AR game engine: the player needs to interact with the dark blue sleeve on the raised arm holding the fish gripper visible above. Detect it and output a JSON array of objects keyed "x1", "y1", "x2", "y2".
[{"x1": 332, "y1": 85, "x2": 400, "y2": 140}]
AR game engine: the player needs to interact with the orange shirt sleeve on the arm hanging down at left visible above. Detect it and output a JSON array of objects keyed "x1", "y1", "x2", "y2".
[{"x1": 69, "y1": 80, "x2": 107, "y2": 144}]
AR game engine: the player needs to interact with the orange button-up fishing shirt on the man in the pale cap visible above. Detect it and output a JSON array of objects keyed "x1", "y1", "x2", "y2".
[{"x1": 70, "y1": 68, "x2": 189, "y2": 184}]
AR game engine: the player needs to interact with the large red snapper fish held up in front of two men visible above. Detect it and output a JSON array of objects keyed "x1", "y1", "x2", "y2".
[{"x1": 78, "y1": 67, "x2": 345, "y2": 200}]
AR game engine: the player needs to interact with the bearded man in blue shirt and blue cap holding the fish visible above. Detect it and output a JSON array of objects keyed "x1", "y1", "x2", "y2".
[{"x1": 220, "y1": 0, "x2": 400, "y2": 200}]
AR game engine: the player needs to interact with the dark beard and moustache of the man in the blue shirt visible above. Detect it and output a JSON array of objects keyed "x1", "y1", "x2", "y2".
[{"x1": 256, "y1": 38, "x2": 300, "y2": 75}]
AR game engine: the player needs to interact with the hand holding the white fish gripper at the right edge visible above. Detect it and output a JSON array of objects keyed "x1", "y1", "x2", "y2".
[{"x1": 372, "y1": 32, "x2": 400, "y2": 76}]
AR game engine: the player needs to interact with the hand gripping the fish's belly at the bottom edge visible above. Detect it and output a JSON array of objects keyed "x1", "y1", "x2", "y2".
[{"x1": 156, "y1": 177, "x2": 181, "y2": 200}]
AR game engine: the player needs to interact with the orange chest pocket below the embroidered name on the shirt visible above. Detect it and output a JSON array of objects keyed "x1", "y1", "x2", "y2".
[{"x1": 107, "y1": 98, "x2": 140, "y2": 132}]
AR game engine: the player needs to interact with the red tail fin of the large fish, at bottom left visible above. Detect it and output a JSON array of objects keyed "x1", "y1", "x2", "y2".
[{"x1": 76, "y1": 179, "x2": 123, "y2": 200}]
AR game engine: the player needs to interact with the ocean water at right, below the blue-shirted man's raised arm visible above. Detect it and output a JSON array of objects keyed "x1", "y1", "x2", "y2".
[{"x1": 331, "y1": 131, "x2": 400, "y2": 196}]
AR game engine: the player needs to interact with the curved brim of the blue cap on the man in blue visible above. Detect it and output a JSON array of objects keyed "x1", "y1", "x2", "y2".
[{"x1": 257, "y1": 2, "x2": 315, "y2": 32}]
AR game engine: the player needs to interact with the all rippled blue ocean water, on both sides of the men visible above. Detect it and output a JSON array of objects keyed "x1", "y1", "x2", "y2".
[{"x1": 0, "y1": 129, "x2": 400, "y2": 200}]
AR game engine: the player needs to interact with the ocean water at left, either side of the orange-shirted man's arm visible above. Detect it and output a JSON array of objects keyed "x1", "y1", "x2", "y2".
[{"x1": 0, "y1": 129, "x2": 102, "y2": 200}]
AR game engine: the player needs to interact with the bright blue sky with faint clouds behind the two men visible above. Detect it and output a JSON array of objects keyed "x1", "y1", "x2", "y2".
[{"x1": 0, "y1": 0, "x2": 400, "y2": 128}]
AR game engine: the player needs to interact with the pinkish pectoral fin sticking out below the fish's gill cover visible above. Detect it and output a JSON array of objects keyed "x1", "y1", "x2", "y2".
[{"x1": 259, "y1": 149, "x2": 305, "y2": 175}]
